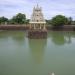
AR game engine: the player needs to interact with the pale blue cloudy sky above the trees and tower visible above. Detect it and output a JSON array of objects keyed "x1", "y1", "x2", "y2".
[{"x1": 0, "y1": 0, "x2": 75, "y2": 20}]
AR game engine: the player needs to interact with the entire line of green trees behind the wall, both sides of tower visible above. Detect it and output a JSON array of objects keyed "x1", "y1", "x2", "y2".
[{"x1": 0, "y1": 13, "x2": 75, "y2": 26}]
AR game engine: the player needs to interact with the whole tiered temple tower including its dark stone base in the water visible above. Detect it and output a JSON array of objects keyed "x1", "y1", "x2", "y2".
[{"x1": 28, "y1": 5, "x2": 47, "y2": 39}]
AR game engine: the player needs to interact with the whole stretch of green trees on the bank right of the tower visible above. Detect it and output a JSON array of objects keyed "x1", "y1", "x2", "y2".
[{"x1": 46, "y1": 15, "x2": 75, "y2": 26}]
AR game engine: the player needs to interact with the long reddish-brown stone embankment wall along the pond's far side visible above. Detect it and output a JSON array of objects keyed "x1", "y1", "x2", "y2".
[{"x1": 0, "y1": 25, "x2": 75, "y2": 31}]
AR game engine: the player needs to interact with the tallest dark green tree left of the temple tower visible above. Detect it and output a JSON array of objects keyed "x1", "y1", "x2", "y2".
[{"x1": 10, "y1": 13, "x2": 26, "y2": 24}]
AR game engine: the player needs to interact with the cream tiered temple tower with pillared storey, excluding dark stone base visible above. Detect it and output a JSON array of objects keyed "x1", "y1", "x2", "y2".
[{"x1": 29, "y1": 4, "x2": 46, "y2": 30}]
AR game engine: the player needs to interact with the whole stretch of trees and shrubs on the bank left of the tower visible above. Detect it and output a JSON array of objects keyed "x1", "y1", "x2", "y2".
[{"x1": 0, "y1": 13, "x2": 29, "y2": 25}]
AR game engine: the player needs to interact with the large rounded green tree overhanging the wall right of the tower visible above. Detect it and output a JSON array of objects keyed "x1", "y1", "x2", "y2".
[{"x1": 51, "y1": 15, "x2": 68, "y2": 26}]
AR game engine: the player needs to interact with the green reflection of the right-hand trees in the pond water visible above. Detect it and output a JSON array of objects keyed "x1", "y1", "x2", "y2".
[{"x1": 48, "y1": 32, "x2": 72, "y2": 45}]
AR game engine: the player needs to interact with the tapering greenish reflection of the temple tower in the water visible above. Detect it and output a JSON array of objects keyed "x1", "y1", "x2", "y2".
[{"x1": 29, "y1": 39, "x2": 47, "y2": 63}]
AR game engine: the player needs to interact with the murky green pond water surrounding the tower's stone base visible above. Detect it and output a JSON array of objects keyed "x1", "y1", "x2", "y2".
[{"x1": 0, "y1": 31, "x2": 75, "y2": 75}]
